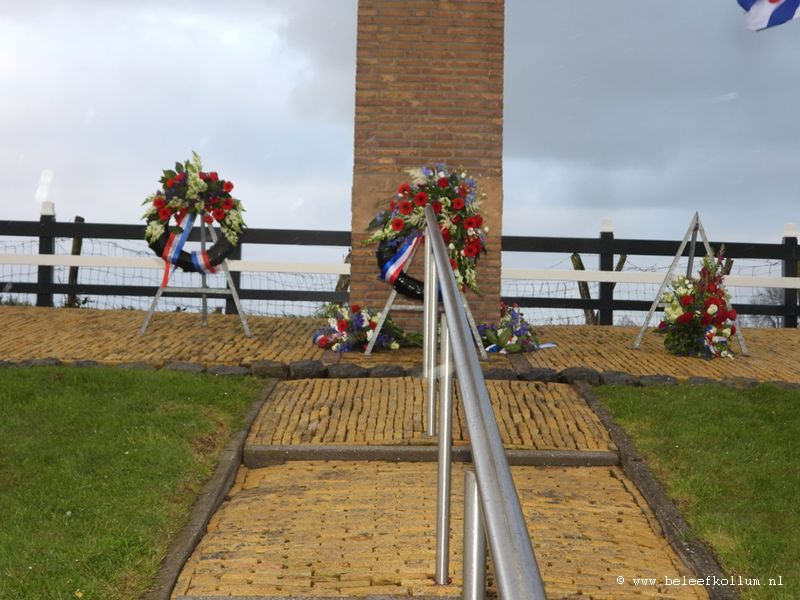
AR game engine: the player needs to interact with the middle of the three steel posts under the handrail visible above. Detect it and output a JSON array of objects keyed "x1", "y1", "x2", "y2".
[{"x1": 436, "y1": 315, "x2": 453, "y2": 585}]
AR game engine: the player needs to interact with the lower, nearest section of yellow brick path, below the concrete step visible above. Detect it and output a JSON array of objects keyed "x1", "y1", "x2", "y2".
[{"x1": 173, "y1": 462, "x2": 707, "y2": 599}]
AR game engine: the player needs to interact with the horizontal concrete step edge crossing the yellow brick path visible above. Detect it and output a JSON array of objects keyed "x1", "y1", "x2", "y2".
[{"x1": 244, "y1": 444, "x2": 619, "y2": 469}]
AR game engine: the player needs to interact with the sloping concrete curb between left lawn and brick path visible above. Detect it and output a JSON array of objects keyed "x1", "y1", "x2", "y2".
[{"x1": 141, "y1": 380, "x2": 277, "y2": 600}]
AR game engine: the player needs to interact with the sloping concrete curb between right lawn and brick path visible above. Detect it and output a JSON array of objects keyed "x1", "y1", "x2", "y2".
[{"x1": 575, "y1": 382, "x2": 739, "y2": 600}]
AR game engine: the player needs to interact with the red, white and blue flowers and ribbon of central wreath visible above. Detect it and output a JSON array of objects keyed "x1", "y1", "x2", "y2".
[{"x1": 364, "y1": 164, "x2": 489, "y2": 292}]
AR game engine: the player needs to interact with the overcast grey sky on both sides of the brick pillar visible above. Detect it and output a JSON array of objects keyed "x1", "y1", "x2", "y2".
[{"x1": 0, "y1": 0, "x2": 800, "y2": 247}]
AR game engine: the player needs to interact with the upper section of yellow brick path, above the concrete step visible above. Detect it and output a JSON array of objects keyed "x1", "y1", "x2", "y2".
[{"x1": 247, "y1": 377, "x2": 614, "y2": 450}]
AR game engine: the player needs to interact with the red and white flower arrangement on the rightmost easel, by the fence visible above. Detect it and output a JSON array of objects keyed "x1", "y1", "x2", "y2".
[{"x1": 658, "y1": 249, "x2": 736, "y2": 358}]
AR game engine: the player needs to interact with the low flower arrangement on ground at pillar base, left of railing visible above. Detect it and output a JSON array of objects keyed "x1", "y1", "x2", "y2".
[{"x1": 311, "y1": 304, "x2": 420, "y2": 352}]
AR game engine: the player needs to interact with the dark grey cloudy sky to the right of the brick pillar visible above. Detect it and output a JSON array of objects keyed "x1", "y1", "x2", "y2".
[{"x1": 505, "y1": 0, "x2": 800, "y2": 239}]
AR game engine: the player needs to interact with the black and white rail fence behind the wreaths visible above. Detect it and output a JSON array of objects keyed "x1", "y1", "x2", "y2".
[{"x1": 0, "y1": 209, "x2": 800, "y2": 327}]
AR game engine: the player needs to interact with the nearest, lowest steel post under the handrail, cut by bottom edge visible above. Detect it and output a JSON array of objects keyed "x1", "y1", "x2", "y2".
[{"x1": 461, "y1": 469, "x2": 486, "y2": 600}]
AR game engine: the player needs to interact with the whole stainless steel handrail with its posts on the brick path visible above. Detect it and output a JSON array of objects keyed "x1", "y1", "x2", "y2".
[{"x1": 424, "y1": 205, "x2": 545, "y2": 600}]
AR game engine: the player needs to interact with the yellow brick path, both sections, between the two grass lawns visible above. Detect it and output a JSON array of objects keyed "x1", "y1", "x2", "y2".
[{"x1": 173, "y1": 377, "x2": 706, "y2": 600}]
